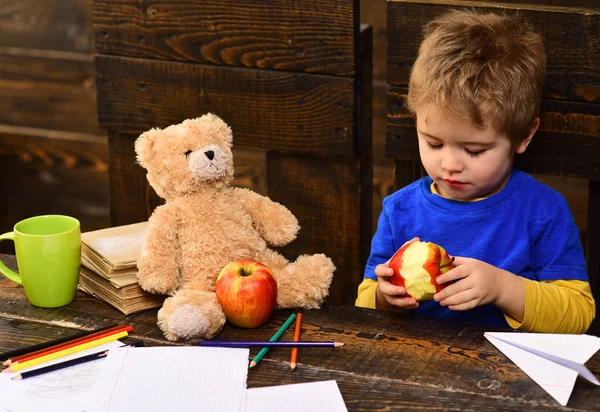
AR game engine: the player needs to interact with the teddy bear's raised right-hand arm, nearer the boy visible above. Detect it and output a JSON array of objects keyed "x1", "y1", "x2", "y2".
[{"x1": 235, "y1": 188, "x2": 300, "y2": 246}]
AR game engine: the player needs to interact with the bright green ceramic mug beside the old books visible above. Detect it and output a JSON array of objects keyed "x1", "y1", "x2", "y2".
[{"x1": 0, "y1": 215, "x2": 81, "y2": 308}]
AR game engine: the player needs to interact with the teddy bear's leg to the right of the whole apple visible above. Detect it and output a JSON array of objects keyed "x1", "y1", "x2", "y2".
[{"x1": 277, "y1": 253, "x2": 335, "y2": 309}]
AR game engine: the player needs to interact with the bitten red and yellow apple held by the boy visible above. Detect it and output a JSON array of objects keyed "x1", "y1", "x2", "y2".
[{"x1": 389, "y1": 240, "x2": 454, "y2": 301}]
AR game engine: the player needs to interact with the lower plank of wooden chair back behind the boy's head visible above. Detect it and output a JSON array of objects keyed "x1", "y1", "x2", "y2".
[{"x1": 385, "y1": 85, "x2": 600, "y2": 180}]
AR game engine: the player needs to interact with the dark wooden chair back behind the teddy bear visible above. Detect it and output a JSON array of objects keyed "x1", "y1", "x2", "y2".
[{"x1": 93, "y1": 0, "x2": 372, "y2": 302}]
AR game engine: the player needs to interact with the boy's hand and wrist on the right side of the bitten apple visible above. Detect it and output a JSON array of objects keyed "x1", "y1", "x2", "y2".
[{"x1": 433, "y1": 257, "x2": 524, "y2": 314}]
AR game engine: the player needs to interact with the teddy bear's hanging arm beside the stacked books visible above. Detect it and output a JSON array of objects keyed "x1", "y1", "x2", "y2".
[{"x1": 137, "y1": 205, "x2": 180, "y2": 295}]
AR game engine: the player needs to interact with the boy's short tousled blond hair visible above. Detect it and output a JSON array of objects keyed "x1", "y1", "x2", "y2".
[{"x1": 407, "y1": 10, "x2": 546, "y2": 145}]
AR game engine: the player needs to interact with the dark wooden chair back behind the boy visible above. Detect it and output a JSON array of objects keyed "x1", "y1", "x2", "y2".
[{"x1": 386, "y1": 0, "x2": 600, "y2": 333}]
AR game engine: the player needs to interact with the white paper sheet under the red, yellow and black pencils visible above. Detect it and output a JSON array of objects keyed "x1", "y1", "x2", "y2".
[{"x1": 0, "y1": 341, "x2": 123, "y2": 412}]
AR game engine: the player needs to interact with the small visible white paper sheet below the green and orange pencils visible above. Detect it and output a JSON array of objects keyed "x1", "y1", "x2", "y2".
[{"x1": 244, "y1": 381, "x2": 348, "y2": 412}]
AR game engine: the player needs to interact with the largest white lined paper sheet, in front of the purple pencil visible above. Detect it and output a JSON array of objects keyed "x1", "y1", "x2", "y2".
[{"x1": 96, "y1": 346, "x2": 250, "y2": 412}]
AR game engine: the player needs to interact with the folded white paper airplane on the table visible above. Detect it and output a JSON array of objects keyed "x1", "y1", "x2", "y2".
[{"x1": 484, "y1": 332, "x2": 600, "y2": 406}]
